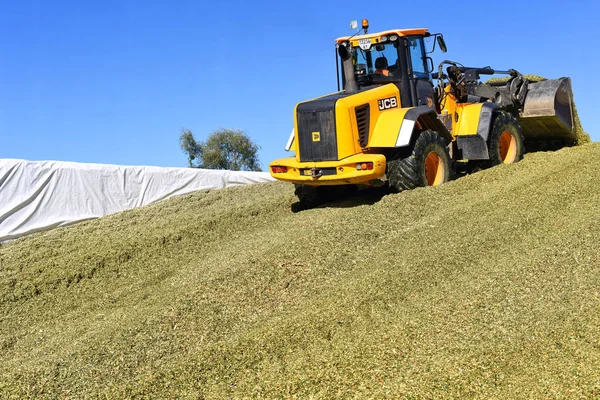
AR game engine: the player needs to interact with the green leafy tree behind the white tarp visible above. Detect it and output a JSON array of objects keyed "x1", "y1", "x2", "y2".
[{"x1": 179, "y1": 128, "x2": 261, "y2": 171}]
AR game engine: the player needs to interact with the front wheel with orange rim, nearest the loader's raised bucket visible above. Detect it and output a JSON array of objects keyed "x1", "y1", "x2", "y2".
[{"x1": 487, "y1": 111, "x2": 525, "y2": 167}]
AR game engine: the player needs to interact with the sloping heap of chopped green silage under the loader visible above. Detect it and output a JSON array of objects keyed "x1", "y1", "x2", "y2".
[{"x1": 0, "y1": 144, "x2": 600, "y2": 398}]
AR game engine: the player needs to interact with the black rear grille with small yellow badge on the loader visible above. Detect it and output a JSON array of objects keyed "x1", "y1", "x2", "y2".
[{"x1": 297, "y1": 107, "x2": 338, "y2": 162}]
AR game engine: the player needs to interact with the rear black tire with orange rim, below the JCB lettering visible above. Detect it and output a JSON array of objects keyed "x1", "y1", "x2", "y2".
[{"x1": 387, "y1": 130, "x2": 452, "y2": 192}]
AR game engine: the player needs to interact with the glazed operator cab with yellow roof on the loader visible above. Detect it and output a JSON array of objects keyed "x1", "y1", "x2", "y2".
[{"x1": 336, "y1": 29, "x2": 435, "y2": 107}]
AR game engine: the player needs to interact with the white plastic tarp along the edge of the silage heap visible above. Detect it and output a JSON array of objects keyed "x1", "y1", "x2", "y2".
[{"x1": 0, "y1": 159, "x2": 273, "y2": 241}]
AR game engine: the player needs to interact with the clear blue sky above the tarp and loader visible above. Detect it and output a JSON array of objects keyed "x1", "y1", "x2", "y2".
[{"x1": 0, "y1": 0, "x2": 600, "y2": 167}]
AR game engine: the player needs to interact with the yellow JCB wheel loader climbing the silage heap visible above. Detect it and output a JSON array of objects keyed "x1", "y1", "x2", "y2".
[{"x1": 269, "y1": 20, "x2": 575, "y2": 205}]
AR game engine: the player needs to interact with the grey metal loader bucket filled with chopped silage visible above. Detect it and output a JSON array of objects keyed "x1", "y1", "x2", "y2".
[{"x1": 519, "y1": 78, "x2": 576, "y2": 142}]
